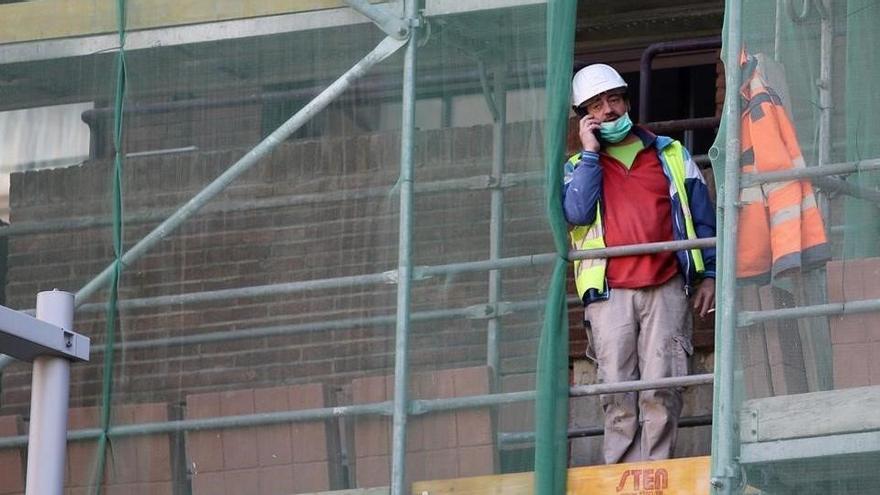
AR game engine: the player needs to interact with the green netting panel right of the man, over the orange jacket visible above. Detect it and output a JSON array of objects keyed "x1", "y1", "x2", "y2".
[{"x1": 712, "y1": 0, "x2": 880, "y2": 494}]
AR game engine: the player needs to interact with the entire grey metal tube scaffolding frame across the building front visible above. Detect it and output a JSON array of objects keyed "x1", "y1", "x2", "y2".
[{"x1": 0, "y1": 0, "x2": 880, "y2": 495}]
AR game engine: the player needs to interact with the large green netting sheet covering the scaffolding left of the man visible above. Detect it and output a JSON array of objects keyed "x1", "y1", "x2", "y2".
[{"x1": 0, "y1": 0, "x2": 560, "y2": 494}]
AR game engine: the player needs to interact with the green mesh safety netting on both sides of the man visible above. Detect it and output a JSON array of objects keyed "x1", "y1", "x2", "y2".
[{"x1": 6, "y1": 0, "x2": 880, "y2": 494}]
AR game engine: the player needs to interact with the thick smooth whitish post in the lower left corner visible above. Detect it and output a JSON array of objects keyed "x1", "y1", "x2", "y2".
[{"x1": 25, "y1": 290, "x2": 73, "y2": 495}]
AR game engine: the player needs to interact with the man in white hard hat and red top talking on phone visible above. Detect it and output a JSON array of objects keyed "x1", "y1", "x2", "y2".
[{"x1": 562, "y1": 64, "x2": 715, "y2": 464}]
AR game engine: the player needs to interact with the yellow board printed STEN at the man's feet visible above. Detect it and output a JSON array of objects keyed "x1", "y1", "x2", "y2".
[{"x1": 412, "y1": 457, "x2": 710, "y2": 495}]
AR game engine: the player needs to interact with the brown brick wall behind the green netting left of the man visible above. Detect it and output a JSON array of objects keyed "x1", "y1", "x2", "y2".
[{"x1": 0, "y1": 125, "x2": 552, "y2": 412}]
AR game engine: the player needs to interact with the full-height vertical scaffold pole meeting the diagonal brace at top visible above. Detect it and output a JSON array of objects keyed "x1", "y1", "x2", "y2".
[{"x1": 391, "y1": 0, "x2": 419, "y2": 495}]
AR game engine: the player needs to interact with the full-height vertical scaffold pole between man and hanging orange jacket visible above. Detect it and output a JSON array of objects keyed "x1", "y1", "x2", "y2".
[{"x1": 711, "y1": 0, "x2": 742, "y2": 495}]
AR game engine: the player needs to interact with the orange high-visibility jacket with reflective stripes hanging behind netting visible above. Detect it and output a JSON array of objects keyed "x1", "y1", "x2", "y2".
[{"x1": 737, "y1": 52, "x2": 831, "y2": 283}]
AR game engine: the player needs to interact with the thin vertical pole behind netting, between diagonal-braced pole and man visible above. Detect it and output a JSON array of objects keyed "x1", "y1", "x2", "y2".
[{"x1": 486, "y1": 63, "x2": 507, "y2": 392}]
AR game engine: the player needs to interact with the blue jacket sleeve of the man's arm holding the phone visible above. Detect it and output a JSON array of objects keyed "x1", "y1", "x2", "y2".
[{"x1": 562, "y1": 151, "x2": 602, "y2": 225}]
